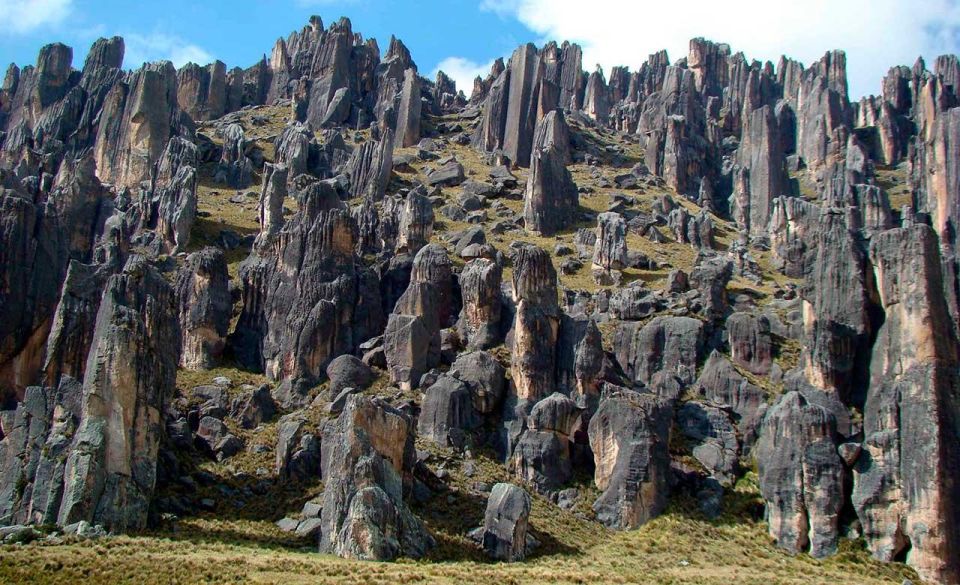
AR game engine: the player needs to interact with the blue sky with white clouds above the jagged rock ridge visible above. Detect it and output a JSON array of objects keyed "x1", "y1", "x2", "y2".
[{"x1": 0, "y1": 0, "x2": 960, "y2": 98}]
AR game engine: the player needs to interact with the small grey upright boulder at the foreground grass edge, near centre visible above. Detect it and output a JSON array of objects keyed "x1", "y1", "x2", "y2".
[{"x1": 483, "y1": 483, "x2": 532, "y2": 563}]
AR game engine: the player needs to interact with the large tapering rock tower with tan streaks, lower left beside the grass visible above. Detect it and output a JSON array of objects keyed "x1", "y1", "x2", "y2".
[{"x1": 57, "y1": 257, "x2": 178, "y2": 531}]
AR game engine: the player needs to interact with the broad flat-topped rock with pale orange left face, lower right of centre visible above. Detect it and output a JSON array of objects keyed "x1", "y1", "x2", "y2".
[{"x1": 589, "y1": 389, "x2": 673, "y2": 529}]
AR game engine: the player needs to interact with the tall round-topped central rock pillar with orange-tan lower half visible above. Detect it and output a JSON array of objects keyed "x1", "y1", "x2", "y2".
[{"x1": 511, "y1": 245, "x2": 560, "y2": 402}]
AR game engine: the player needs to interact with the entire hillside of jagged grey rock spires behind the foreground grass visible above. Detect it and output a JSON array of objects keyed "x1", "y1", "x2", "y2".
[{"x1": 0, "y1": 12, "x2": 960, "y2": 585}]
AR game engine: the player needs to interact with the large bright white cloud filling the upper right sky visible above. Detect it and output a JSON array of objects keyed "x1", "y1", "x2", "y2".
[{"x1": 480, "y1": 0, "x2": 960, "y2": 98}]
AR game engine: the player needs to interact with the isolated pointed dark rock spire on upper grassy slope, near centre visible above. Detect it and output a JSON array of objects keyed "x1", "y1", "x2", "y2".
[{"x1": 523, "y1": 111, "x2": 580, "y2": 236}]
